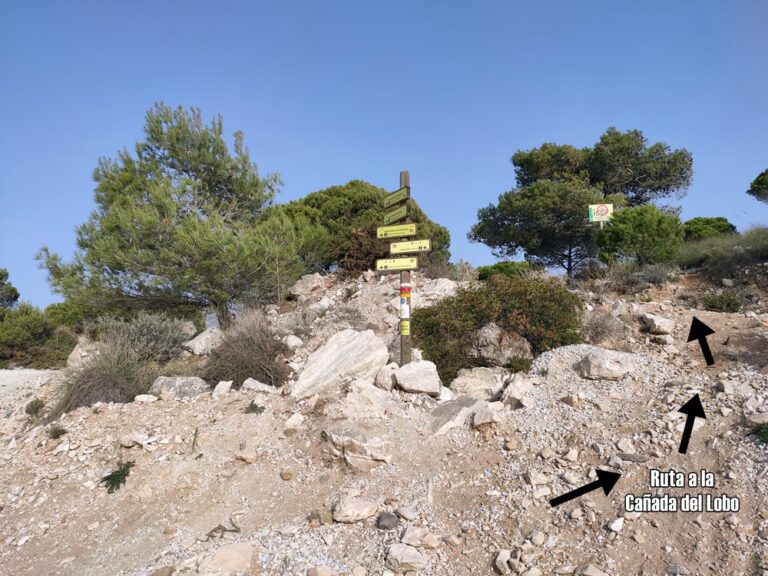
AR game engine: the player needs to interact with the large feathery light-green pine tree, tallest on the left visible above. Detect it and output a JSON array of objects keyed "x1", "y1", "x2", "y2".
[{"x1": 38, "y1": 104, "x2": 280, "y2": 326}]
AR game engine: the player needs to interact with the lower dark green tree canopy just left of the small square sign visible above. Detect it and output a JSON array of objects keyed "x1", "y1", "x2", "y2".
[{"x1": 469, "y1": 179, "x2": 624, "y2": 276}]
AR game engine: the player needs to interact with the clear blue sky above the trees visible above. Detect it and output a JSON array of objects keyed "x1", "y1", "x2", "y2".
[{"x1": 0, "y1": 0, "x2": 768, "y2": 306}]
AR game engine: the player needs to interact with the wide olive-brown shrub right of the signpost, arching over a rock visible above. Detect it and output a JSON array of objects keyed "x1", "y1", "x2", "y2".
[{"x1": 413, "y1": 275, "x2": 581, "y2": 382}]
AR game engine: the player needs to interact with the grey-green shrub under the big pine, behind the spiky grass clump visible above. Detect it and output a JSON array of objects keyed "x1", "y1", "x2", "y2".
[{"x1": 93, "y1": 311, "x2": 189, "y2": 362}]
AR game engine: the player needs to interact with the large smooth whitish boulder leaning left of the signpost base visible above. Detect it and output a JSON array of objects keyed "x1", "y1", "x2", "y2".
[{"x1": 291, "y1": 329, "x2": 389, "y2": 398}]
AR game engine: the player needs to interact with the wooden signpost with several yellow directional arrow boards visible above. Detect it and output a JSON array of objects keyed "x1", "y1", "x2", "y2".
[{"x1": 376, "y1": 170, "x2": 432, "y2": 366}]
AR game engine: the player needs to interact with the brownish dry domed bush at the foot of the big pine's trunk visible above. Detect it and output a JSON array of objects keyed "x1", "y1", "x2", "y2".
[{"x1": 204, "y1": 311, "x2": 290, "y2": 386}]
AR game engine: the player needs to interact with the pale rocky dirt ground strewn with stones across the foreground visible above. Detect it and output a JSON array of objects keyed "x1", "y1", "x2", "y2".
[{"x1": 0, "y1": 274, "x2": 768, "y2": 576}]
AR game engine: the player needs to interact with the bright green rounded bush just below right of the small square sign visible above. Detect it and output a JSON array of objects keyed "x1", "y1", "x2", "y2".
[{"x1": 597, "y1": 205, "x2": 683, "y2": 264}]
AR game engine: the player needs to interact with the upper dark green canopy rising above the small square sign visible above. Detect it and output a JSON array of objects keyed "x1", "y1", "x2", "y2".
[{"x1": 512, "y1": 128, "x2": 693, "y2": 206}]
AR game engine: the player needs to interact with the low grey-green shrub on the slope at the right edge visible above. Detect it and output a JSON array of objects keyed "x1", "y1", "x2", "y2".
[{"x1": 675, "y1": 226, "x2": 768, "y2": 280}]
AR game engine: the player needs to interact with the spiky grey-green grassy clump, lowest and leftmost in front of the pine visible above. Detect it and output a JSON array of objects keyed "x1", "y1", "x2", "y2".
[{"x1": 51, "y1": 333, "x2": 157, "y2": 418}]
